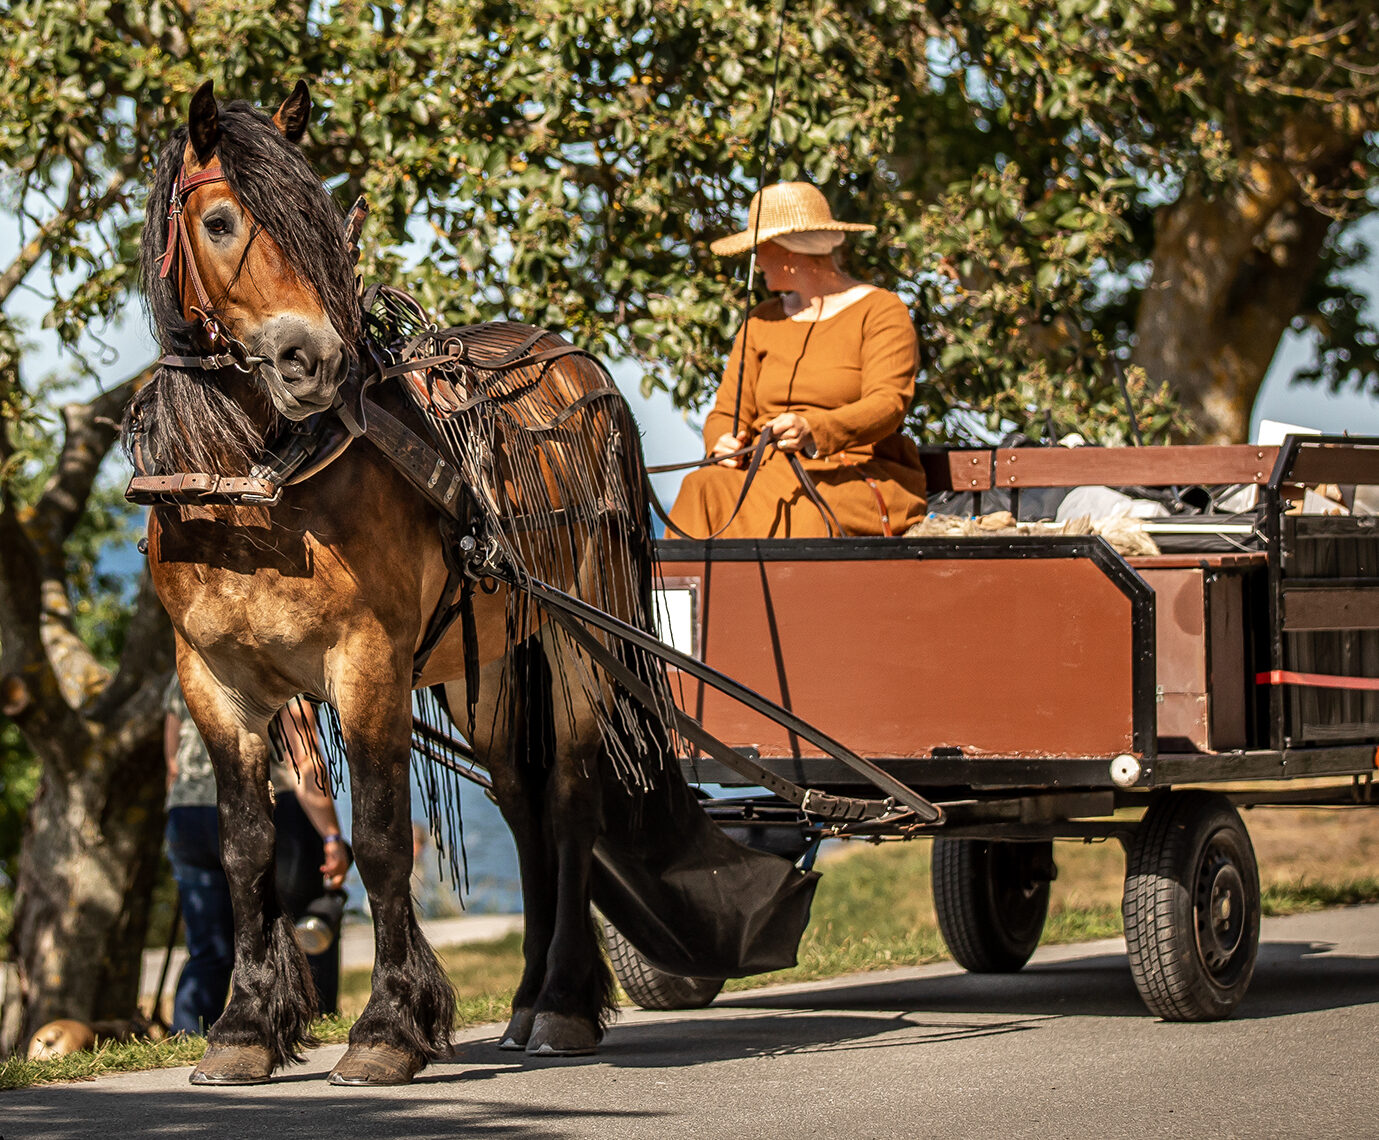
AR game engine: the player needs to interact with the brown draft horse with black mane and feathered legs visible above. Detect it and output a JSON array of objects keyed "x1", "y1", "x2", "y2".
[{"x1": 127, "y1": 83, "x2": 683, "y2": 1083}]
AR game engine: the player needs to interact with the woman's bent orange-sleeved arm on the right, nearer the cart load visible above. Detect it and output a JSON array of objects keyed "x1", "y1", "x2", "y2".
[{"x1": 808, "y1": 294, "x2": 918, "y2": 455}]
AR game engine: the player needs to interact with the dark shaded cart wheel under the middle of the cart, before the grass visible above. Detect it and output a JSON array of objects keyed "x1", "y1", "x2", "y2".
[{"x1": 932, "y1": 838, "x2": 1056, "y2": 973}]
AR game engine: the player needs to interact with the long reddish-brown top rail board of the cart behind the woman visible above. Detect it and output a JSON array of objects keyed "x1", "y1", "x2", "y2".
[{"x1": 993, "y1": 444, "x2": 1274, "y2": 487}]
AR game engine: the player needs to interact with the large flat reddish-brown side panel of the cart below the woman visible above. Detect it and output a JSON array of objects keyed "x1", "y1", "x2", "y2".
[{"x1": 662, "y1": 558, "x2": 1134, "y2": 758}]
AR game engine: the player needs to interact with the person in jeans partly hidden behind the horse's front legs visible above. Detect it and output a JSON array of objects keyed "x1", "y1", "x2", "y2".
[{"x1": 163, "y1": 677, "x2": 350, "y2": 1034}]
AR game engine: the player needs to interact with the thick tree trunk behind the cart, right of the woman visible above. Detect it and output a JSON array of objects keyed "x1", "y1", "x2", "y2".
[{"x1": 1134, "y1": 119, "x2": 1358, "y2": 442}]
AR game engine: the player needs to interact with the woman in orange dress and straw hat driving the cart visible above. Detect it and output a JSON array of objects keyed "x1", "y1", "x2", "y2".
[{"x1": 670, "y1": 182, "x2": 924, "y2": 538}]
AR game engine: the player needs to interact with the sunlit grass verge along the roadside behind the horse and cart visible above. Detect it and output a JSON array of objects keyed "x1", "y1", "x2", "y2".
[{"x1": 10, "y1": 842, "x2": 1379, "y2": 1089}]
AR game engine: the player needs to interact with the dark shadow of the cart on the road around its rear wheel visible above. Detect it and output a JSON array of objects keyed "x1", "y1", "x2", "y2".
[{"x1": 716, "y1": 941, "x2": 1379, "y2": 1019}]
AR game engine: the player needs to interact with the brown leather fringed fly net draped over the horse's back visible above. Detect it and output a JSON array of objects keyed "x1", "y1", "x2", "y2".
[{"x1": 365, "y1": 289, "x2": 674, "y2": 791}]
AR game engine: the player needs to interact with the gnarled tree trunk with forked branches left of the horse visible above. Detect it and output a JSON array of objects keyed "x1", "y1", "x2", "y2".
[{"x1": 0, "y1": 372, "x2": 172, "y2": 1053}]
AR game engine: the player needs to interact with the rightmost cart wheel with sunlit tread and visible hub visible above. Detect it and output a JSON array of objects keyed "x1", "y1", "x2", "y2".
[{"x1": 1123, "y1": 791, "x2": 1259, "y2": 1021}]
